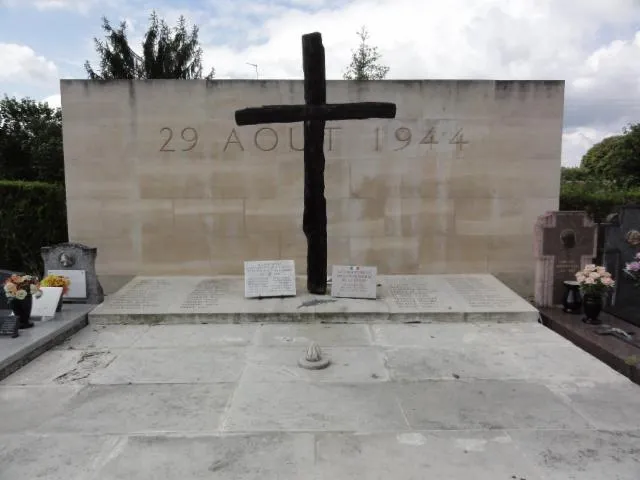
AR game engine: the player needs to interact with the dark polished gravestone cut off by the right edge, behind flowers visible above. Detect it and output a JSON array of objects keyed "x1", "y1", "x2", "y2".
[{"x1": 603, "y1": 205, "x2": 640, "y2": 326}]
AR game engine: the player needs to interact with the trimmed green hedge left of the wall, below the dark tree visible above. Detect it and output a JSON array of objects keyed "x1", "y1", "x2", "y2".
[{"x1": 0, "y1": 180, "x2": 68, "y2": 275}]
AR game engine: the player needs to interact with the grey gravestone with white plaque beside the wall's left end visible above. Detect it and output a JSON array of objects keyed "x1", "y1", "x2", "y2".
[{"x1": 41, "y1": 243, "x2": 104, "y2": 305}]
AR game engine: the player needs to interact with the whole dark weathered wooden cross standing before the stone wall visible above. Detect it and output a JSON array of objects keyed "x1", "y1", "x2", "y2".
[{"x1": 236, "y1": 32, "x2": 396, "y2": 295}]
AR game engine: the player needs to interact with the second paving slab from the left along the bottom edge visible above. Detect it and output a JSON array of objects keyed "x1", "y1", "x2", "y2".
[{"x1": 93, "y1": 433, "x2": 318, "y2": 480}]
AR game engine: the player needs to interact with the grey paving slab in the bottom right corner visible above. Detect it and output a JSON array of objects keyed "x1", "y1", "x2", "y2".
[{"x1": 509, "y1": 430, "x2": 640, "y2": 480}]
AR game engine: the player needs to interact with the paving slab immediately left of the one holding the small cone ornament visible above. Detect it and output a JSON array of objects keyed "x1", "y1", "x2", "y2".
[{"x1": 91, "y1": 347, "x2": 245, "y2": 384}]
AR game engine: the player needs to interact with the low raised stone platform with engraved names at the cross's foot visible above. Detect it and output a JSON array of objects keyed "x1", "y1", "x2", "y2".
[{"x1": 89, "y1": 274, "x2": 539, "y2": 324}]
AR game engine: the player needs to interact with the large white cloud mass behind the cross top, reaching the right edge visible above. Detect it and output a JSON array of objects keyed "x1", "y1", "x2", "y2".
[{"x1": 196, "y1": 0, "x2": 640, "y2": 164}]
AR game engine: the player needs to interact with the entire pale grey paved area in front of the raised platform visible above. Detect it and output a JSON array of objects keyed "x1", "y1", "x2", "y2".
[{"x1": 0, "y1": 321, "x2": 640, "y2": 480}]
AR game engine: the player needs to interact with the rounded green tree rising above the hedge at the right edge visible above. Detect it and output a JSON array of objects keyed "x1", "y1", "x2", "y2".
[{"x1": 580, "y1": 123, "x2": 640, "y2": 188}]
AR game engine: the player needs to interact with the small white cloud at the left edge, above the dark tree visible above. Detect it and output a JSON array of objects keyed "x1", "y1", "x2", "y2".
[{"x1": 0, "y1": 43, "x2": 58, "y2": 84}]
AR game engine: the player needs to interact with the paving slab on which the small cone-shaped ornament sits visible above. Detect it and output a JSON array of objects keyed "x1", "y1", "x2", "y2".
[{"x1": 242, "y1": 347, "x2": 389, "y2": 383}]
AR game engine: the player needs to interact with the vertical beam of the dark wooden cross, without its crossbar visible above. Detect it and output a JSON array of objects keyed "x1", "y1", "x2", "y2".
[{"x1": 302, "y1": 33, "x2": 327, "y2": 295}]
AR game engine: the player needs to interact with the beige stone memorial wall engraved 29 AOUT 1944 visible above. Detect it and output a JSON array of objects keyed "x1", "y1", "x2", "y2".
[{"x1": 61, "y1": 80, "x2": 564, "y2": 295}]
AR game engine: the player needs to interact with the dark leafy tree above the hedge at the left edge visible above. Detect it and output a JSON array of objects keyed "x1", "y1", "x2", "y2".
[{"x1": 0, "y1": 95, "x2": 64, "y2": 183}]
